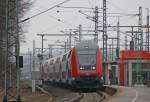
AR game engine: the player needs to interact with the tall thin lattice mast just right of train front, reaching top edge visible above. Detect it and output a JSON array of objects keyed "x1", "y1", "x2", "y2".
[{"x1": 103, "y1": 0, "x2": 107, "y2": 61}]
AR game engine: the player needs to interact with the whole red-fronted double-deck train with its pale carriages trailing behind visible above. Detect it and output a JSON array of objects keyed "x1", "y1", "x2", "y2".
[{"x1": 42, "y1": 41, "x2": 103, "y2": 88}]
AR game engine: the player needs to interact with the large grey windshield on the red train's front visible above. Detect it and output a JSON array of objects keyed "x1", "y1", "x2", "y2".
[{"x1": 77, "y1": 49, "x2": 97, "y2": 66}]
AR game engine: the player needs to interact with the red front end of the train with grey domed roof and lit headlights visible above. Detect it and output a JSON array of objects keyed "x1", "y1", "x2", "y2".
[{"x1": 72, "y1": 41, "x2": 102, "y2": 88}]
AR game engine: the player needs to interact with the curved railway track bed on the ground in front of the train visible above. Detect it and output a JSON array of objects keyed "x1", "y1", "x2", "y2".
[{"x1": 41, "y1": 82, "x2": 105, "y2": 102}]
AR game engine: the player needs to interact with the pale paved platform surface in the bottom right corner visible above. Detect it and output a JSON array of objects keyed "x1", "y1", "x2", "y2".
[{"x1": 106, "y1": 87, "x2": 150, "y2": 102}]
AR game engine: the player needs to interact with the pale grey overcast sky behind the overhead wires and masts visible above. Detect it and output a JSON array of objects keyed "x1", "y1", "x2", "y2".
[{"x1": 21, "y1": 0, "x2": 150, "y2": 52}]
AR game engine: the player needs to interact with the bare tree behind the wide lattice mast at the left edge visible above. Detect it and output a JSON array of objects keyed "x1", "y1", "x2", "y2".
[{"x1": 0, "y1": 0, "x2": 32, "y2": 90}]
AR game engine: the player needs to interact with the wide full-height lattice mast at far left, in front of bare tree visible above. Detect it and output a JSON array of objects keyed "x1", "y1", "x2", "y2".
[{"x1": 3, "y1": 0, "x2": 20, "y2": 102}]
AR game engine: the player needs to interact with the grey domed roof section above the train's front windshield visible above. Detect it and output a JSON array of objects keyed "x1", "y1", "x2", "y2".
[{"x1": 75, "y1": 40, "x2": 98, "y2": 49}]
